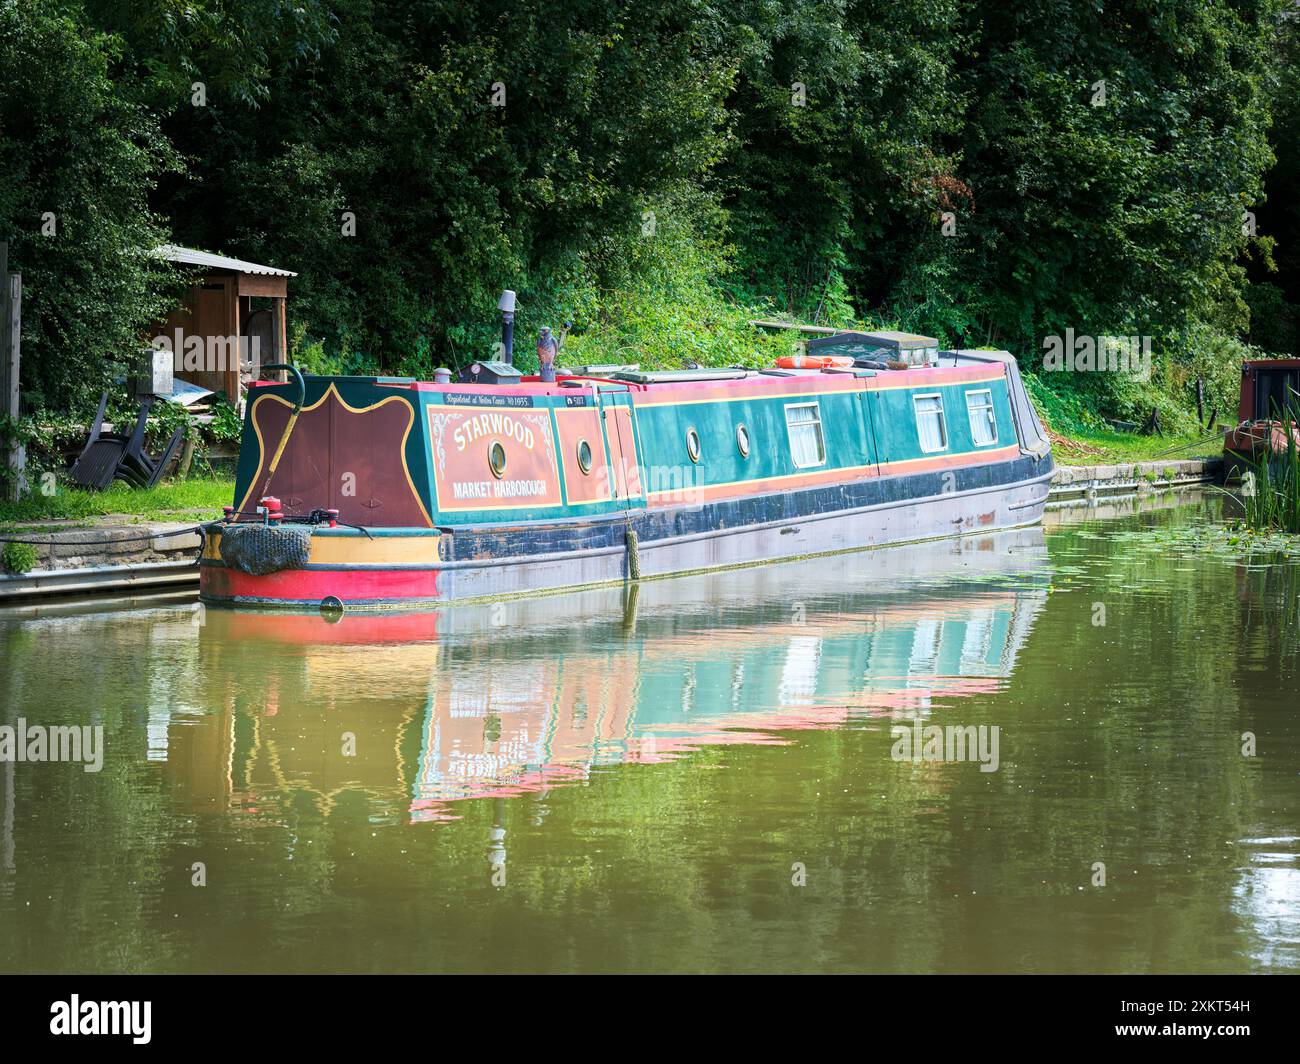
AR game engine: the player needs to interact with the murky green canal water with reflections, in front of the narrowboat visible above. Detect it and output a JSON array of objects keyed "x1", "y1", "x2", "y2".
[{"x1": 0, "y1": 498, "x2": 1300, "y2": 972}]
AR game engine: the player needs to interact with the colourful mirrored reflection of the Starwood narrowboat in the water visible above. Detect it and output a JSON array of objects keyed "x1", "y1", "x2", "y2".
[{"x1": 188, "y1": 528, "x2": 1048, "y2": 822}]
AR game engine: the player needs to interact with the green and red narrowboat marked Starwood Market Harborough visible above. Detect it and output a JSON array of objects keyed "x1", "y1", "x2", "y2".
[{"x1": 200, "y1": 333, "x2": 1053, "y2": 610}]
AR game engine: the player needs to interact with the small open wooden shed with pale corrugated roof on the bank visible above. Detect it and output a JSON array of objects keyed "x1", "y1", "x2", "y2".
[{"x1": 150, "y1": 245, "x2": 298, "y2": 405}]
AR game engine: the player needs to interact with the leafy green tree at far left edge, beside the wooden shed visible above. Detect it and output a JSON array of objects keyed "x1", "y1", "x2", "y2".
[{"x1": 0, "y1": 0, "x2": 183, "y2": 407}]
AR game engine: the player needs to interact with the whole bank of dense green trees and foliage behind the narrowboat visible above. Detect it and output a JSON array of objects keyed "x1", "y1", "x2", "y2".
[{"x1": 0, "y1": 0, "x2": 1300, "y2": 426}]
